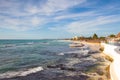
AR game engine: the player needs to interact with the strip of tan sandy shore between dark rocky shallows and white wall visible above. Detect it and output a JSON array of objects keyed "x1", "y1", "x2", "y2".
[{"x1": 73, "y1": 41, "x2": 111, "y2": 80}]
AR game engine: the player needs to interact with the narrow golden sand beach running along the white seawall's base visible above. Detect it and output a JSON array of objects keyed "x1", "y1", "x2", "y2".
[{"x1": 73, "y1": 41, "x2": 112, "y2": 80}]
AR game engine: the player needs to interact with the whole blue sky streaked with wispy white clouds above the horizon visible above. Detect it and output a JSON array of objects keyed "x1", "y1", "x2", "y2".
[{"x1": 0, "y1": 0, "x2": 120, "y2": 39}]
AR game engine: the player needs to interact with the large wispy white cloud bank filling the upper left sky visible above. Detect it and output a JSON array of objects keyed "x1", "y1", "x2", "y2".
[{"x1": 0, "y1": 0, "x2": 86, "y2": 31}]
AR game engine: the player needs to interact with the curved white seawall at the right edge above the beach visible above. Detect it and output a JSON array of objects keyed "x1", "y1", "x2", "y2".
[{"x1": 101, "y1": 43, "x2": 120, "y2": 80}]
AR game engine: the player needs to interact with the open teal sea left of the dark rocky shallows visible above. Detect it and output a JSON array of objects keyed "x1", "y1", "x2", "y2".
[{"x1": 0, "y1": 39, "x2": 78, "y2": 78}]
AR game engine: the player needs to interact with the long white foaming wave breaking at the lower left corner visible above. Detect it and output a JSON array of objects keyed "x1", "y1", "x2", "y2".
[{"x1": 0, "y1": 66, "x2": 43, "y2": 79}]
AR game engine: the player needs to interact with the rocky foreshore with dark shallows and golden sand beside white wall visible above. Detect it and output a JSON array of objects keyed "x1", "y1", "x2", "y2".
[{"x1": 0, "y1": 41, "x2": 111, "y2": 80}]
